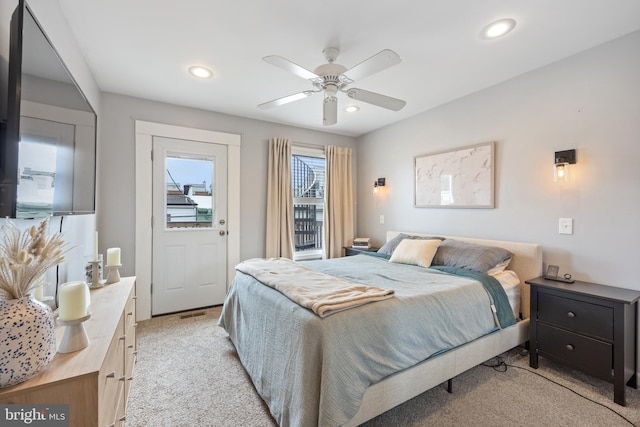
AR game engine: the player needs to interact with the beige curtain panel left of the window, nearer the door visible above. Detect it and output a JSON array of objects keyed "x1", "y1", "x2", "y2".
[{"x1": 265, "y1": 138, "x2": 293, "y2": 258}]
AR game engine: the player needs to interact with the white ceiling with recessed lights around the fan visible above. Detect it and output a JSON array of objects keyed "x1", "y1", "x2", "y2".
[{"x1": 58, "y1": 0, "x2": 640, "y2": 136}]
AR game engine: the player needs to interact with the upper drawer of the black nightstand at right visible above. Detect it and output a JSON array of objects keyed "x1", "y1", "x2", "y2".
[{"x1": 538, "y1": 292, "x2": 614, "y2": 341}]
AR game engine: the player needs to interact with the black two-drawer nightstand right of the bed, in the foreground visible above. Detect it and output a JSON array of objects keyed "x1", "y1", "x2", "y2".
[{"x1": 525, "y1": 277, "x2": 640, "y2": 406}]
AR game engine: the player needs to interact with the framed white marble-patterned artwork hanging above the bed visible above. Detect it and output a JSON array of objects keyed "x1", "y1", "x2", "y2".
[{"x1": 413, "y1": 141, "x2": 495, "y2": 208}]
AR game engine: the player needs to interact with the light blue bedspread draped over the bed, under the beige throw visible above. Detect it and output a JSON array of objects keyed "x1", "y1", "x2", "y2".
[{"x1": 219, "y1": 255, "x2": 516, "y2": 426}]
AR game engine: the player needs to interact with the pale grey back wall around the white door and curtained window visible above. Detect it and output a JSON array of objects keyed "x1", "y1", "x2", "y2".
[{"x1": 98, "y1": 93, "x2": 357, "y2": 276}]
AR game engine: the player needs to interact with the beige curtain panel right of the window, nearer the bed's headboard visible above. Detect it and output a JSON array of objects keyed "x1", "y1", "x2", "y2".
[{"x1": 324, "y1": 145, "x2": 354, "y2": 258}]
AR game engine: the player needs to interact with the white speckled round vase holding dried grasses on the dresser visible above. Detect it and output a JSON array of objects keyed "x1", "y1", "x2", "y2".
[{"x1": 0, "y1": 295, "x2": 56, "y2": 388}]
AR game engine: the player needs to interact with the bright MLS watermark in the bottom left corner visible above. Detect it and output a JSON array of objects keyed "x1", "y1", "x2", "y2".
[{"x1": 0, "y1": 404, "x2": 69, "y2": 427}]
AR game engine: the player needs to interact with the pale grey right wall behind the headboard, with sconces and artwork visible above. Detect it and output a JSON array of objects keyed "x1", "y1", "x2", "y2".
[{"x1": 358, "y1": 32, "x2": 640, "y2": 289}]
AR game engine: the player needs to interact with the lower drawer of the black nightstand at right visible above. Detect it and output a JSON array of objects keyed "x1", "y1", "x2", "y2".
[{"x1": 537, "y1": 324, "x2": 613, "y2": 381}]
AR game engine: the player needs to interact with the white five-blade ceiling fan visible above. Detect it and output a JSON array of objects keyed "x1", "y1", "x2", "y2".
[{"x1": 258, "y1": 47, "x2": 406, "y2": 126}]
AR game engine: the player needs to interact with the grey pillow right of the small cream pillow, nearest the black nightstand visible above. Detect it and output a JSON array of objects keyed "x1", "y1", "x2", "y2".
[{"x1": 431, "y1": 239, "x2": 513, "y2": 273}]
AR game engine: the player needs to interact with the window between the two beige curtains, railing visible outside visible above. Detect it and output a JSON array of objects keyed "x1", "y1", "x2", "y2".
[{"x1": 291, "y1": 147, "x2": 326, "y2": 259}]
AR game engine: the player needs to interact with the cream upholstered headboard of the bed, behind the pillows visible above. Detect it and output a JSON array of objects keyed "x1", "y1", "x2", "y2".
[{"x1": 387, "y1": 231, "x2": 542, "y2": 319}]
